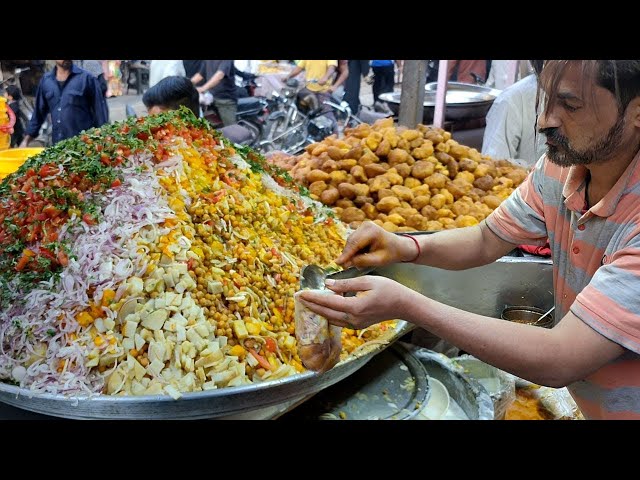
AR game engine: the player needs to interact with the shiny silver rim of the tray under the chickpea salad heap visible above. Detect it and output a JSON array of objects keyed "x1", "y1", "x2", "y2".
[{"x1": 0, "y1": 320, "x2": 413, "y2": 420}]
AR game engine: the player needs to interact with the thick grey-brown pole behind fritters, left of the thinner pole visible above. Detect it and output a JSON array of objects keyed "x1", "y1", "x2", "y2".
[{"x1": 398, "y1": 60, "x2": 427, "y2": 128}]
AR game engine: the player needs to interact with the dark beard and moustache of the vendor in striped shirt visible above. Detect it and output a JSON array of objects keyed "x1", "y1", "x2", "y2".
[{"x1": 538, "y1": 115, "x2": 624, "y2": 167}]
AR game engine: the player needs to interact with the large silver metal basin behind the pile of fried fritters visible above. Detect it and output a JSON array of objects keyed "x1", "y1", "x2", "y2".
[{"x1": 380, "y1": 82, "x2": 500, "y2": 123}]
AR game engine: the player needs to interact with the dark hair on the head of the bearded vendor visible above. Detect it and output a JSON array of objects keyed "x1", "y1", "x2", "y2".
[{"x1": 539, "y1": 60, "x2": 640, "y2": 113}]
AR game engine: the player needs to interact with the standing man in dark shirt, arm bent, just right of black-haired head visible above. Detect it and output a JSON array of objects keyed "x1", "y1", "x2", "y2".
[{"x1": 191, "y1": 60, "x2": 238, "y2": 127}]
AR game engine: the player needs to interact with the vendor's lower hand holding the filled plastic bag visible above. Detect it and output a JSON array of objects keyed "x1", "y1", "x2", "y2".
[{"x1": 300, "y1": 276, "x2": 418, "y2": 330}]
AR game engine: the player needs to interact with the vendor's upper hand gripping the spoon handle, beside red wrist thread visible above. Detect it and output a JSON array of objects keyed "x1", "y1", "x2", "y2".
[{"x1": 336, "y1": 221, "x2": 418, "y2": 268}]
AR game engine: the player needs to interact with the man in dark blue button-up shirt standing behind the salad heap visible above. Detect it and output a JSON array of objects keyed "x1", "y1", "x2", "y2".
[{"x1": 20, "y1": 60, "x2": 109, "y2": 147}]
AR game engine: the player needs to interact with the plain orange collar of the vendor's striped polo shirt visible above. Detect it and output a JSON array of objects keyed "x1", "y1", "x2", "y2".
[{"x1": 562, "y1": 152, "x2": 640, "y2": 217}]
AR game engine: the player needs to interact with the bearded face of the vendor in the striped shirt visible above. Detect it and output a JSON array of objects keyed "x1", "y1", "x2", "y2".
[{"x1": 538, "y1": 62, "x2": 632, "y2": 167}]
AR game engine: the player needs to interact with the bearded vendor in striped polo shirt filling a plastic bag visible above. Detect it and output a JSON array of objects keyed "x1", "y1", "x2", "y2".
[{"x1": 301, "y1": 60, "x2": 640, "y2": 419}]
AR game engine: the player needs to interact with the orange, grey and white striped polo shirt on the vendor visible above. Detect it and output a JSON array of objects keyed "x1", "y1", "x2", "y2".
[{"x1": 487, "y1": 154, "x2": 640, "y2": 419}]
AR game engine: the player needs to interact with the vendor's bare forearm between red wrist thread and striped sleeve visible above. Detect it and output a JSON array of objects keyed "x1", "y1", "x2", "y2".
[{"x1": 415, "y1": 222, "x2": 515, "y2": 270}]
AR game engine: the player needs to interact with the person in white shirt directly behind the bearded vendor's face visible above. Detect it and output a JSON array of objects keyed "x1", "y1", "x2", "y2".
[{"x1": 482, "y1": 60, "x2": 546, "y2": 169}]
